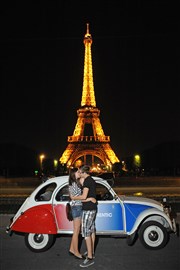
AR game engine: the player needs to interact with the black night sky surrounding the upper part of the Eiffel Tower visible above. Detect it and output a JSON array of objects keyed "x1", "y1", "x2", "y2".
[{"x1": 0, "y1": 0, "x2": 180, "y2": 159}]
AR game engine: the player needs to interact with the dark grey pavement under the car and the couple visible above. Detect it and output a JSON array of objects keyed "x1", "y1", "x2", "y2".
[{"x1": 0, "y1": 214, "x2": 180, "y2": 270}]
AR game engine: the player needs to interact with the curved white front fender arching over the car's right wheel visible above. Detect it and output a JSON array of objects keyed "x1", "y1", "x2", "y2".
[{"x1": 127, "y1": 208, "x2": 172, "y2": 235}]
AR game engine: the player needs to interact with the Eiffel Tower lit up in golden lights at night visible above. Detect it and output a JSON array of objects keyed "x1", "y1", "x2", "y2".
[{"x1": 59, "y1": 24, "x2": 120, "y2": 169}]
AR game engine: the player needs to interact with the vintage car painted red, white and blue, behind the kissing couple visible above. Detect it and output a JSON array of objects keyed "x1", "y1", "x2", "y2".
[{"x1": 6, "y1": 176, "x2": 177, "y2": 252}]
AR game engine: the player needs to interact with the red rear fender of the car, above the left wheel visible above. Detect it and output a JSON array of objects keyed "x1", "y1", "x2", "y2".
[{"x1": 11, "y1": 205, "x2": 57, "y2": 234}]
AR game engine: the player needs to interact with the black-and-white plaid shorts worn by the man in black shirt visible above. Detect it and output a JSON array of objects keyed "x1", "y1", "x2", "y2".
[{"x1": 81, "y1": 210, "x2": 97, "y2": 238}]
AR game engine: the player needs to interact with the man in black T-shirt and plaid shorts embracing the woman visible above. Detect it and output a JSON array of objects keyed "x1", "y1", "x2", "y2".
[{"x1": 71, "y1": 165, "x2": 97, "y2": 267}]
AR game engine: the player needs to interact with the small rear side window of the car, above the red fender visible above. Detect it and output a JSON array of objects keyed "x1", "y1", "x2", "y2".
[{"x1": 35, "y1": 183, "x2": 56, "y2": 201}]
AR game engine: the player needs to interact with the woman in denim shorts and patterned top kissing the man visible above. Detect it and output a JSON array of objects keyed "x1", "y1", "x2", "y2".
[{"x1": 69, "y1": 168, "x2": 96, "y2": 259}]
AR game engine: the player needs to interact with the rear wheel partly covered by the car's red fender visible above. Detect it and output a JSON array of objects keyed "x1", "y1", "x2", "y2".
[{"x1": 25, "y1": 233, "x2": 55, "y2": 253}]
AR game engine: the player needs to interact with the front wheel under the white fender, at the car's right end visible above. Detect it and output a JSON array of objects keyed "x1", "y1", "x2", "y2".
[{"x1": 139, "y1": 221, "x2": 169, "y2": 250}]
